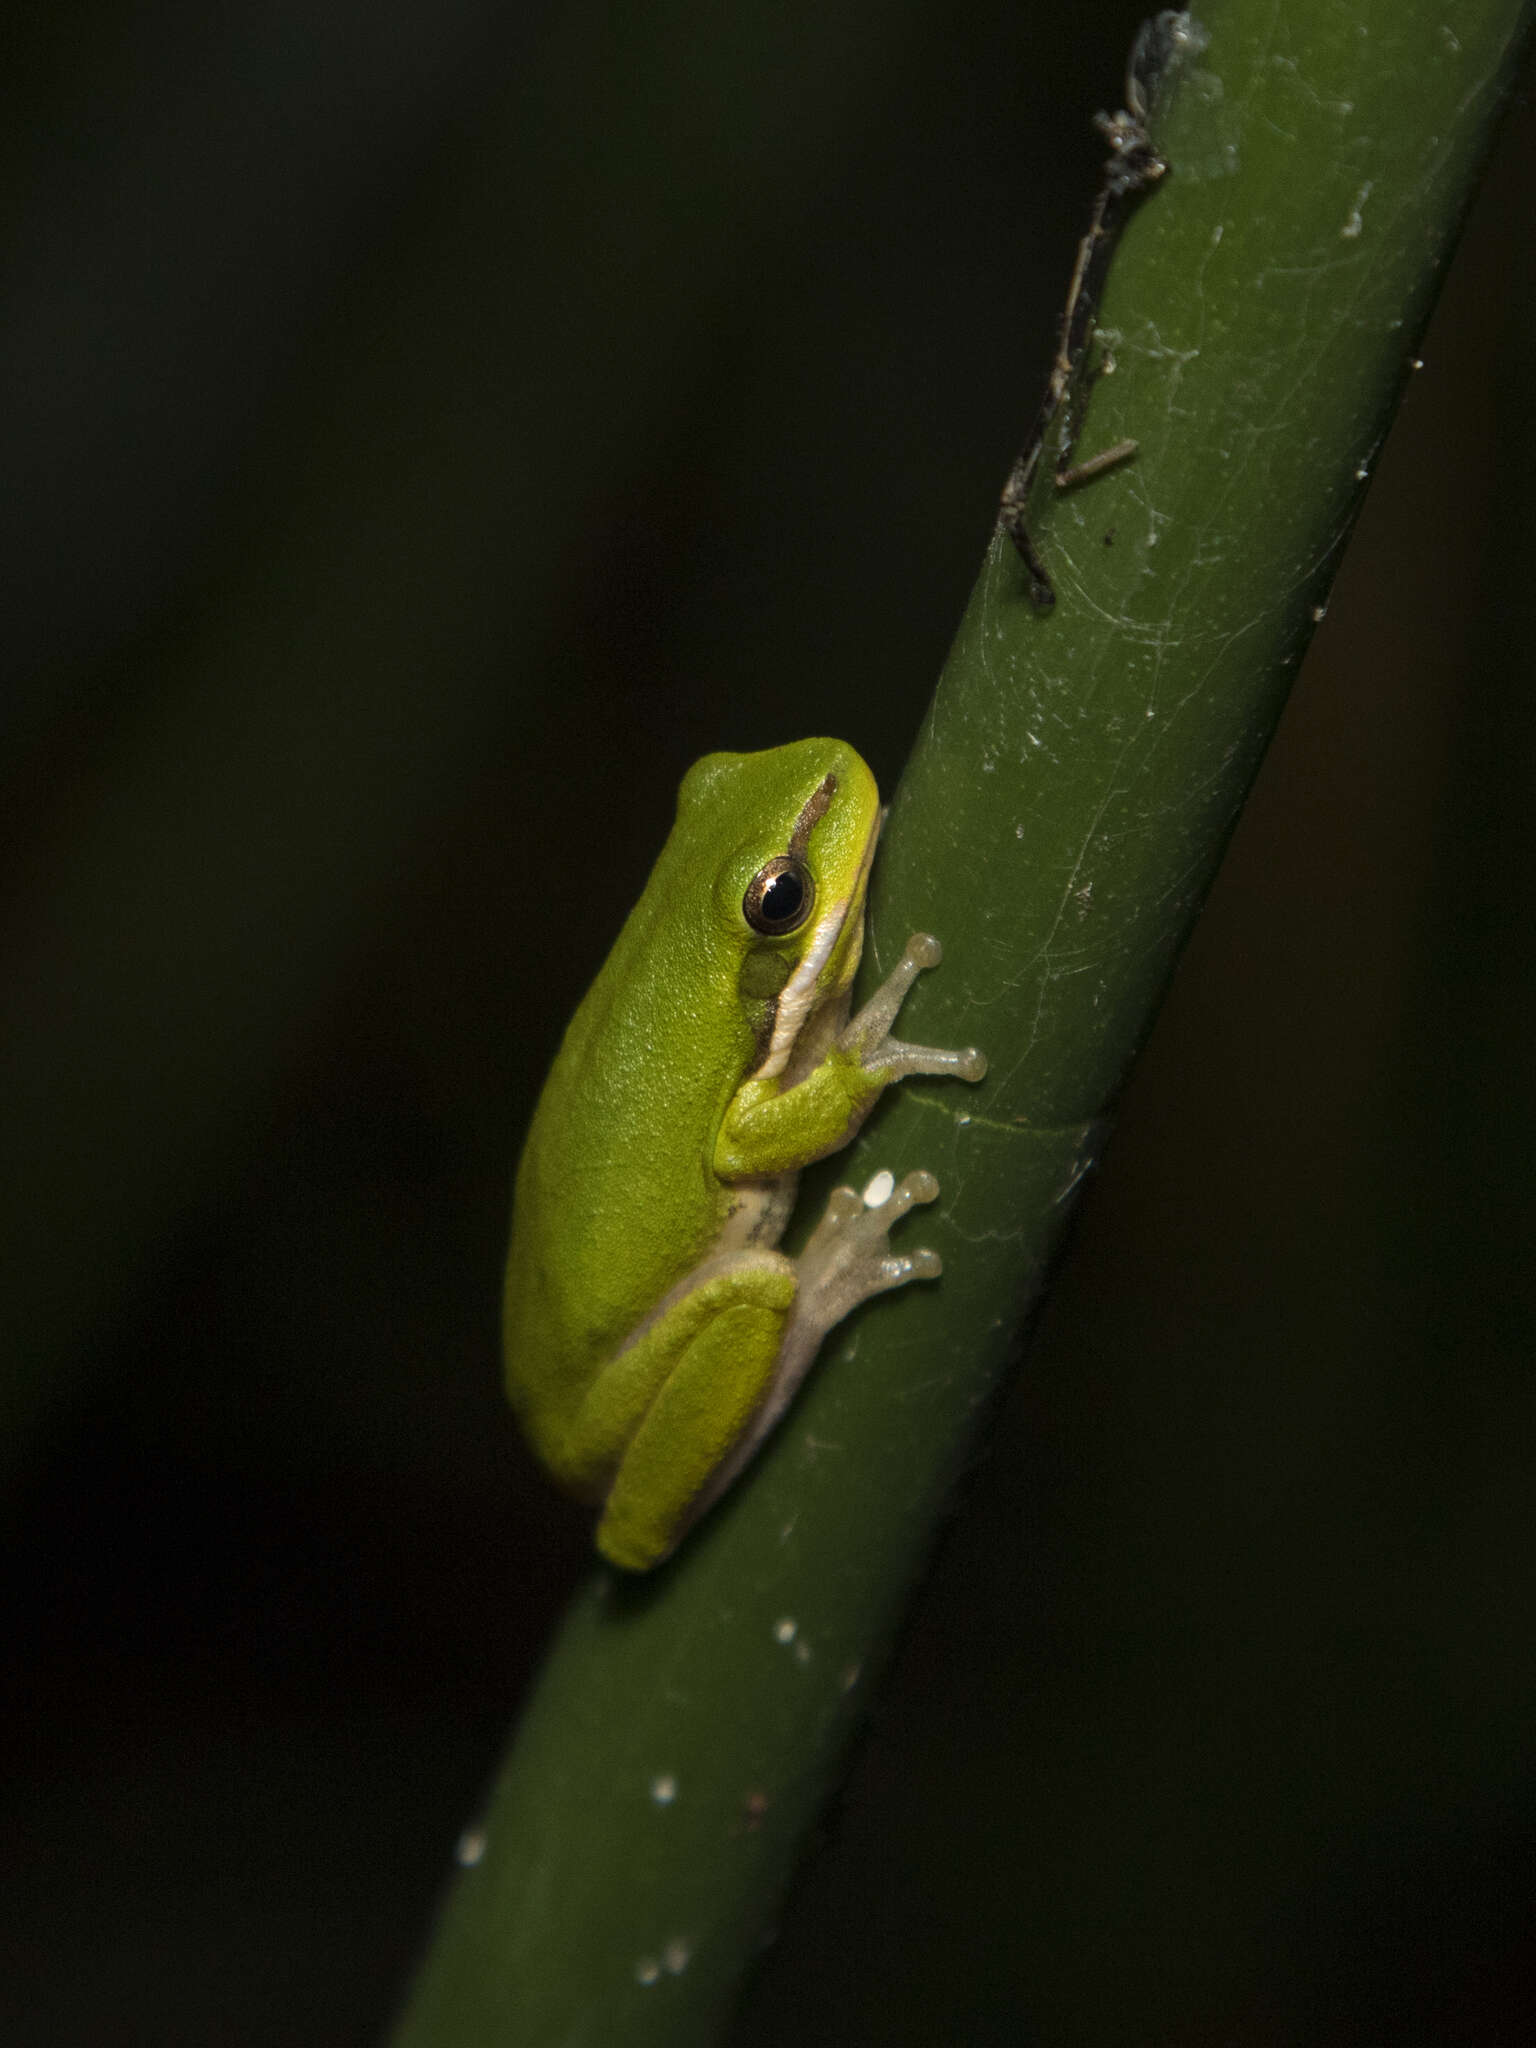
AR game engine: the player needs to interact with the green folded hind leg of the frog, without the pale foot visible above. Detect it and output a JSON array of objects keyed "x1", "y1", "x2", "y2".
[{"x1": 598, "y1": 1257, "x2": 795, "y2": 1571}]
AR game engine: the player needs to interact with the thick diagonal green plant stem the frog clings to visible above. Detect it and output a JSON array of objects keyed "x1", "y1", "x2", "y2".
[{"x1": 395, "y1": 0, "x2": 1530, "y2": 2048}]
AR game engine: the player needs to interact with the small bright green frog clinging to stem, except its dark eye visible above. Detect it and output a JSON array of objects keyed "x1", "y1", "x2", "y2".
[{"x1": 504, "y1": 739, "x2": 985, "y2": 1571}]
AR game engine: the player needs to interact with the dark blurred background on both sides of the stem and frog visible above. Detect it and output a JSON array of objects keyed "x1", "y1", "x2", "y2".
[{"x1": 0, "y1": 0, "x2": 1536, "y2": 2048}]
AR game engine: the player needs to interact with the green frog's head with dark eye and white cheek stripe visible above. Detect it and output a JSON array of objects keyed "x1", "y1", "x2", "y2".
[{"x1": 678, "y1": 739, "x2": 881, "y2": 1077}]
